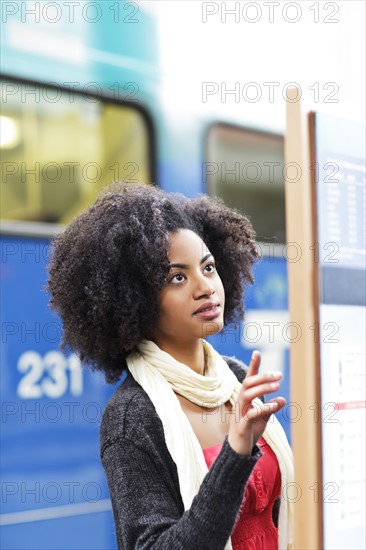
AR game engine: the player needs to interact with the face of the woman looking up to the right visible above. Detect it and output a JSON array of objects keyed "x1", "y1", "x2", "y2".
[{"x1": 154, "y1": 229, "x2": 225, "y2": 347}]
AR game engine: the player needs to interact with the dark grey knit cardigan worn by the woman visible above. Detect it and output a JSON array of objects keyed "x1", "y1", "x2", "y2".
[{"x1": 100, "y1": 357, "x2": 268, "y2": 550}]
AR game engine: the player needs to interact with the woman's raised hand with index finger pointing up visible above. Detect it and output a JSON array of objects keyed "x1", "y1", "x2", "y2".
[{"x1": 228, "y1": 351, "x2": 286, "y2": 456}]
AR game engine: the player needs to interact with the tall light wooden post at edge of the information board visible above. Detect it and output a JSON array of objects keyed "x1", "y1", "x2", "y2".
[{"x1": 285, "y1": 88, "x2": 323, "y2": 550}]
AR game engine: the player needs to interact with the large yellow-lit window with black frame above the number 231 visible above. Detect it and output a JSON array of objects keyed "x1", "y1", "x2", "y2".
[{"x1": 0, "y1": 80, "x2": 154, "y2": 224}]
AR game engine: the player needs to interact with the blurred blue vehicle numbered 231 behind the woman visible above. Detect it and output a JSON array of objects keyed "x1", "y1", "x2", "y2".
[{"x1": 0, "y1": 0, "x2": 290, "y2": 550}]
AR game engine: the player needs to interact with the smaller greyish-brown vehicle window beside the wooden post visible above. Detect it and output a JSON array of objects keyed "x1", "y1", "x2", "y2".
[{"x1": 206, "y1": 123, "x2": 285, "y2": 243}]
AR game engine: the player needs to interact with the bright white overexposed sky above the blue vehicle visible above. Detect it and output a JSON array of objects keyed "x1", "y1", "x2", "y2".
[{"x1": 139, "y1": 0, "x2": 366, "y2": 129}]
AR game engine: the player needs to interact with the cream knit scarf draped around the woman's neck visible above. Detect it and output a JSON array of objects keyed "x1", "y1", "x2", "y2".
[{"x1": 127, "y1": 340, "x2": 294, "y2": 550}]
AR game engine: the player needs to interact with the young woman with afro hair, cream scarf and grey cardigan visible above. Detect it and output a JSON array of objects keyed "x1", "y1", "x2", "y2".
[{"x1": 48, "y1": 183, "x2": 293, "y2": 550}]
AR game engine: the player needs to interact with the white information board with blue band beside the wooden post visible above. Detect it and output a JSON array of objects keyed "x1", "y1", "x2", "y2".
[{"x1": 310, "y1": 114, "x2": 366, "y2": 550}]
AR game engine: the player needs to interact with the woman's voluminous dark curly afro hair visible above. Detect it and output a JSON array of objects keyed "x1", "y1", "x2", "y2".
[{"x1": 46, "y1": 182, "x2": 259, "y2": 383}]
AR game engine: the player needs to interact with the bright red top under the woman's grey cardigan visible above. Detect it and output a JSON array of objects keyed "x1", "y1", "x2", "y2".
[{"x1": 203, "y1": 437, "x2": 281, "y2": 550}]
